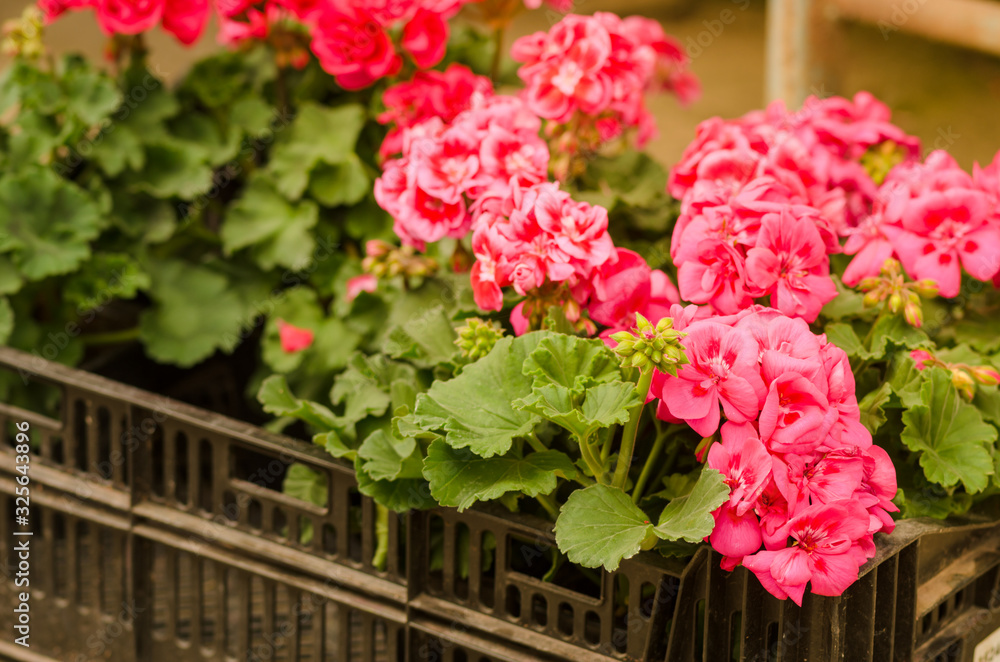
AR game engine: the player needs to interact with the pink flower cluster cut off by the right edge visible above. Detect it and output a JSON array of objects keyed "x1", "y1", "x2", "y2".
[{"x1": 844, "y1": 151, "x2": 1000, "y2": 297}]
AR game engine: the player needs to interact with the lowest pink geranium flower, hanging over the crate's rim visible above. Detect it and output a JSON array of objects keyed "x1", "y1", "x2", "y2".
[{"x1": 743, "y1": 501, "x2": 868, "y2": 606}]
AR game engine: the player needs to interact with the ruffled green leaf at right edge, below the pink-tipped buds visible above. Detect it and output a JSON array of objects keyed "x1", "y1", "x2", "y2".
[{"x1": 902, "y1": 368, "x2": 997, "y2": 494}]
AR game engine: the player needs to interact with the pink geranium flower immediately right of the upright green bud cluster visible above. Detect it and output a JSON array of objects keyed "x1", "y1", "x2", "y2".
[{"x1": 660, "y1": 321, "x2": 765, "y2": 437}]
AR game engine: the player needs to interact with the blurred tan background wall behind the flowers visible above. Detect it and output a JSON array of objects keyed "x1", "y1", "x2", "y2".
[{"x1": 0, "y1": 0, "x2": 1000, "y2": 167}]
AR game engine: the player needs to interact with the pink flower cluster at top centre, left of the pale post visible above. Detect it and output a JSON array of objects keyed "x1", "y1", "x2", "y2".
[{"x1": 511, "y1": 12, "x2": 699, "y2": 145}]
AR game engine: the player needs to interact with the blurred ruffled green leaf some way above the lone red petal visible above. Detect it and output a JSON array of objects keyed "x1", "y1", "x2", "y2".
[{"x1": 221, "y1": 177, "x2": 319, "y2": 270}]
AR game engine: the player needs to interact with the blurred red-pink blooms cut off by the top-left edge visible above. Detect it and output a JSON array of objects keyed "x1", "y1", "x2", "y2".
[{"x1": 38, "y1": 0, "x2": 209, "y2": 45}]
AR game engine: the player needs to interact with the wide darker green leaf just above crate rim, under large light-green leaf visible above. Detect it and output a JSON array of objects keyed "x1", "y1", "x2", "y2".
[{"x1": 424, "y1": 439, "x2": 576, "y2": 511}]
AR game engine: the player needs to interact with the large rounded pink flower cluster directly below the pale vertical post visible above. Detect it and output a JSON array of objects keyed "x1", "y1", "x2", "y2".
[{"x1": 669, "y1": 93, "x2": 919, "y2": 322}]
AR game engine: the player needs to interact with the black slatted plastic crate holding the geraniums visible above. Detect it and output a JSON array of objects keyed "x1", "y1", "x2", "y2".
[{"x1": 0, "y1": 348, "x2": 1000, "y2": 662}]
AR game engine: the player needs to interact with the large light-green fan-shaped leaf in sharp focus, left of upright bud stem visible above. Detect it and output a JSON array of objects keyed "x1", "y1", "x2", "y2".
[{"x1": 415, "y1": 331, "x2": 548, "y2": 457}]
